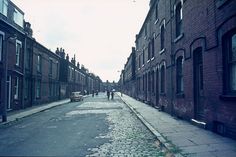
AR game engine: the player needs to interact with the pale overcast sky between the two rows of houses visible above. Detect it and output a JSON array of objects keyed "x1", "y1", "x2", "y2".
[{"x1": 12, "y1": 0, "x2": 149, "y2": 82}]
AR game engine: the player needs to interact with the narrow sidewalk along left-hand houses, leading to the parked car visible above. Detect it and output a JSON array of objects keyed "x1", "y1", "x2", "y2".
[{"x1": 0, "y1": 99, "x2": 70, "y2": 125}]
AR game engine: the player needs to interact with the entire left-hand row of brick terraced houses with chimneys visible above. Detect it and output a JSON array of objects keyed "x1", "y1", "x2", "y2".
[{"x1": 0, "y1": 0, "x2": 102, "y2": 118}]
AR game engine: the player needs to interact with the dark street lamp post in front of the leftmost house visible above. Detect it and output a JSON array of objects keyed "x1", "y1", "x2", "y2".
[{"x1": 2, "y1": 34, "x2": 17, "y2": 122}]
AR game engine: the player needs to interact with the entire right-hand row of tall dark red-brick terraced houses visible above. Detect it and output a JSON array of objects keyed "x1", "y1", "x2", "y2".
[{"x1": 119, "y1": 0, "x2": 236, "y2": 139}]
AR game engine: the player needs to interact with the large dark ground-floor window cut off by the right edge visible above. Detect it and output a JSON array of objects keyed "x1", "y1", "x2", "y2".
[{"x1": 223, "y1": 30, "x2": 236, "y2": 94}]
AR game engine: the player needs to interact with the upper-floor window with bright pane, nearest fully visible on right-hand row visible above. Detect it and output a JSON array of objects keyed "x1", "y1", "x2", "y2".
[{"x1": 175, "y1": 2, "x2": 183, "y2": 37}]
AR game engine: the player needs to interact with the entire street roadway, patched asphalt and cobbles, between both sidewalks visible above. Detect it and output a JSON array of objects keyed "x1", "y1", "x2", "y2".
[{"x1": 0, "y1": 93, "x2": 166, "y2": 156}]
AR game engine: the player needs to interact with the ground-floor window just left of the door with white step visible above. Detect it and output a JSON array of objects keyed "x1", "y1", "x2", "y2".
[{"x1": 176, "y1": 56, "x2": 184, "y2": 93}]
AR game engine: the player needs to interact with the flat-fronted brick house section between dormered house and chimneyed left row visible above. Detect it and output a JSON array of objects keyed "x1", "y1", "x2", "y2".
[{"x1": 31, "y1": 41, "x2": 60, "y2": 104}]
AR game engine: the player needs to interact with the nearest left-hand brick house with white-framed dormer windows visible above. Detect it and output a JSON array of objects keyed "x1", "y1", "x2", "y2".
[{"x1": 0, "y1": 0, "x2": 25, "y2": 111}]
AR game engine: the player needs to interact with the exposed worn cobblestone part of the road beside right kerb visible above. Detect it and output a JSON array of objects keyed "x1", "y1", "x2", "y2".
[{"x1": 78, "y1": 95, "x2": 169, "y2": 157}]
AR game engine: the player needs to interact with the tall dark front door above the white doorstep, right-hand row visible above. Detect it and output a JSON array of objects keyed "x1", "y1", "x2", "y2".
[{"x1": 193, "y1": 48, "x2": 204, "y2": 120}]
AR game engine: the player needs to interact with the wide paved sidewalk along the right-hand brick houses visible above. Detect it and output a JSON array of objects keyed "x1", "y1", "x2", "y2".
[{"x1": 118, "y1": 93, "x2": 236, "y2": 157}]
